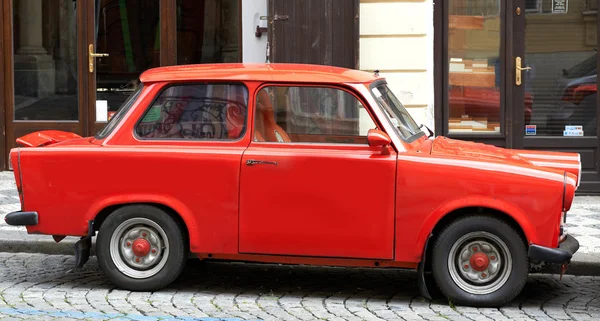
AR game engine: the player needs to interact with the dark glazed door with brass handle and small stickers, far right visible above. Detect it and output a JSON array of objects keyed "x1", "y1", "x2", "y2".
[{"x1": 510, "y1": 0, "x2": 600, "y2": 194}]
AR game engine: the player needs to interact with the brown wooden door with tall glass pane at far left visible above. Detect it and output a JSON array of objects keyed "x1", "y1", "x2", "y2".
[{"x1": 0, "y1": 0, "x2": 88, "y2": 168}]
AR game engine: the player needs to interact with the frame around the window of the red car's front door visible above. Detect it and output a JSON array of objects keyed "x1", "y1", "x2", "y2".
[{"x1": 250, "y1": 82, "x2": 386, "y2": 149}]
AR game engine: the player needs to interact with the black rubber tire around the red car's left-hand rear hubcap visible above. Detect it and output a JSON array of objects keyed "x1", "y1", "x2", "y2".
[{"x1": 96, "y1": 204, "x2": 189, "y2": 291}]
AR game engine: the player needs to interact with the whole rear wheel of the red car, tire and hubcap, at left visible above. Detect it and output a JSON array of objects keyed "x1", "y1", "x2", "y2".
[{"x1": 96, "y1": 205, "x2": 188, "y2": 291}]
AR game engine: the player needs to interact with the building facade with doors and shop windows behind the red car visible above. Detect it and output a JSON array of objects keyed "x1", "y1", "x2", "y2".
[{"x1": 0, "y1": 0, "x2": 600, "y2": 193}]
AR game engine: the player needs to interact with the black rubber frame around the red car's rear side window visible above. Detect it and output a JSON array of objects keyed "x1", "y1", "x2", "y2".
[{"x1": 131, "y1": 80, "x2": 252, "y2": 144}]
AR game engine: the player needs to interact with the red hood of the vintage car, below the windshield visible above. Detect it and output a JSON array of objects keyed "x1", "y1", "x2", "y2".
[{"x1": 430, "y1": 136, "x2": 581, "y2": 186}]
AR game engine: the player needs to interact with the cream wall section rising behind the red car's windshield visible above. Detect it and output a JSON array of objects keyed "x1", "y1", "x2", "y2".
[{"x1": 359, "y1": 0, "x2": 434, "y2": 129}]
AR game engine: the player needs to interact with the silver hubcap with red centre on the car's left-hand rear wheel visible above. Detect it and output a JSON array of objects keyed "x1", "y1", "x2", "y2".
[{"x1": 110, "y1": 218, "x2": 169, "y2": 279}]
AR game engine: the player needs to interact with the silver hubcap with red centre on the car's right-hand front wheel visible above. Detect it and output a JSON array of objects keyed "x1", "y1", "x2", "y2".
[{"x1": 448, "y1": 232, "x2": 512, "y2": 294}]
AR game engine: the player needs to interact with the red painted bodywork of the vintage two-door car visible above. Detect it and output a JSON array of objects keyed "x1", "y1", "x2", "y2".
[{"x1": 11, "y1": 64, "x2": 580, "y2": 267}]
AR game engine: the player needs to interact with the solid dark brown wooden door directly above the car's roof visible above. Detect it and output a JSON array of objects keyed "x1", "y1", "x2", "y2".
[{"x1": 269, "y1": 0, "x2": 359, "y2": 68}]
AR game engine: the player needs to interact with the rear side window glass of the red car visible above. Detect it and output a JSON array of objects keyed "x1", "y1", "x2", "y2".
[{"x1": 135, "y1": 84, "x2": 248, "y2": 140}]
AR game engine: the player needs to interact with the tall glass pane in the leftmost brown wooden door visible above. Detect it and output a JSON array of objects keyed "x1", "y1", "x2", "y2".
[{"x1": 12, "y1": 0, "x2": 79, "y2": 121}]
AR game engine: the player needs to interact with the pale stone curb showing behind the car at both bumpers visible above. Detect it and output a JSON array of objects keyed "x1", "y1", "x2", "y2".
[{"x1": 0, "y1": 231, "x2": 600, "y2": 276}]
